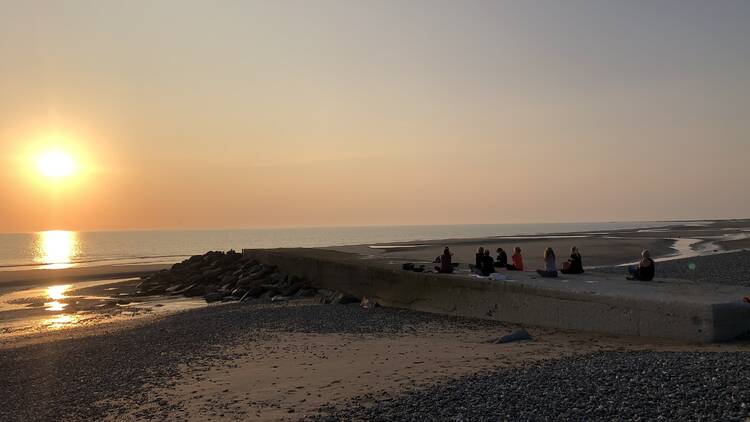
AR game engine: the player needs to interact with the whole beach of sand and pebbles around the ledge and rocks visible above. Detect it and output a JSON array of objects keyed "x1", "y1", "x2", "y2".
[{"x1": 0, "y1": 219, "x2": 750, "y2": 421}]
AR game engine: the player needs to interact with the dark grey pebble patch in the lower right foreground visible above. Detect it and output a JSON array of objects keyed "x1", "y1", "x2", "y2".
[{"x1": 312, "y1": 352, "x2": 750, "y2": 421}]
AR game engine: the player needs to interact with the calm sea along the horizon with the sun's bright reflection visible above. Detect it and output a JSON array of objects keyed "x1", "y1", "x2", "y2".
[{"x1": 0, "y1": 221, "x2": 668, "y2": 270}]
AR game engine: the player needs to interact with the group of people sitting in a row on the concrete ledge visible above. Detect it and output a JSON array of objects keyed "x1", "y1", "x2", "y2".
[{"x1": 435, "y1": 246, "x2": 656, "y2": 281}]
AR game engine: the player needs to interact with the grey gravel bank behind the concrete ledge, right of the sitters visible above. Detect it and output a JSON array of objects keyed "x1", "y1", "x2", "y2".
[{"x1": 592, "y1": 251, "x2": 750, "y2": 287}]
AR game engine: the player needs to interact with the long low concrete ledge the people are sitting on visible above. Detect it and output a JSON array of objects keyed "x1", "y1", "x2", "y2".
[{"x1": 243, "y1": 249, "x2": 750, "y2": 342}]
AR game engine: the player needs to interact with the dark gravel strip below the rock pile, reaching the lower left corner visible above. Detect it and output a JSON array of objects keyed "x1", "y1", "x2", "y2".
[{"x1": 0, "y1": 303, "x2": 497, "y2": 421}]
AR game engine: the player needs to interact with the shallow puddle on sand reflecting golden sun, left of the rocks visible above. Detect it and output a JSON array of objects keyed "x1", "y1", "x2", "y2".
[{"x1": 0, "y1": 279, "x2": 206, "y2": 339}]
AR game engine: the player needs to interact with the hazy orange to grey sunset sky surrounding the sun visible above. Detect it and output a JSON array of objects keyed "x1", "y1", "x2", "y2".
[{"x1": 0, "y1": 0, "x2": 750, "y2": 231}]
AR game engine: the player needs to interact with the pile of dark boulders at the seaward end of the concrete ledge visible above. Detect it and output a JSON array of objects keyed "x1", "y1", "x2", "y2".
[{"x1": 137, "y1": 250, "x2": 368, "y2": 304}]
